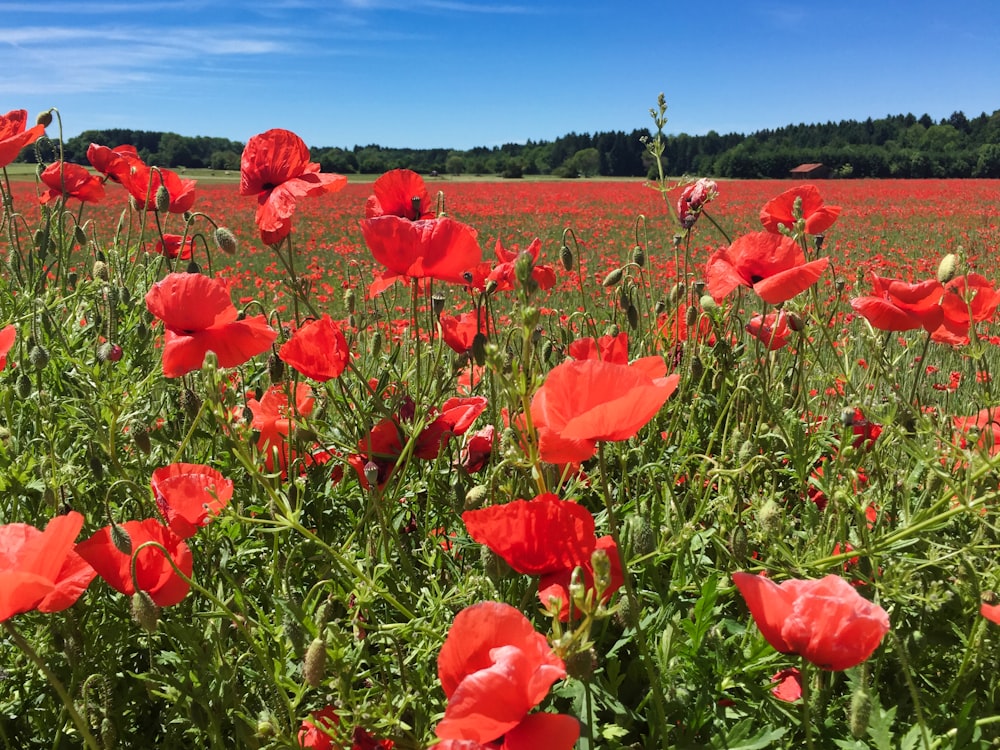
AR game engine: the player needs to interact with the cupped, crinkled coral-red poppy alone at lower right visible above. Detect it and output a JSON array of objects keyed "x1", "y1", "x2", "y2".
[{"x1": 733, "y1": 572, "x2": 889, "y2": 671}]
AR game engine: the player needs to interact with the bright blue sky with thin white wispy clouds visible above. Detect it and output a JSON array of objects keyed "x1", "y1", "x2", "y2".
[{"x1": 0, "y1": 0, "x2": 1000, "y2": 149}]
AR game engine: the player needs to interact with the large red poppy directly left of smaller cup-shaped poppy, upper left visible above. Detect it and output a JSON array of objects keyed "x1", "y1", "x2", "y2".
[{"x1": 146, "y1": 273, "x2": 278, "y2": 378}]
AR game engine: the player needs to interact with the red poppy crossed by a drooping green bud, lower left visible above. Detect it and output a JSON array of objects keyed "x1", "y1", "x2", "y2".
[{"x1": 76, "y1": 518, "x2": 194, "y2": 607}]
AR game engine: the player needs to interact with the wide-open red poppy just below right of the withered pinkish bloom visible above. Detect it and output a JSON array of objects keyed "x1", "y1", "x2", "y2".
[{"x1": 705, "y1": 232, "x2": 830, "y2": 305}]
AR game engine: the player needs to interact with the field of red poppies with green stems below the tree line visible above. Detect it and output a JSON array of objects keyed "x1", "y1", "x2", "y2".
[{"x1": 0, "y1": 107, "x2": 1000, "y2": 750}]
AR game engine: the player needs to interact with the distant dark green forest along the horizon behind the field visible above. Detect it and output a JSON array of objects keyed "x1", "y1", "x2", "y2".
[{"x1": 21, "y1": 110, "x2": 1000, "y2": 178}]
